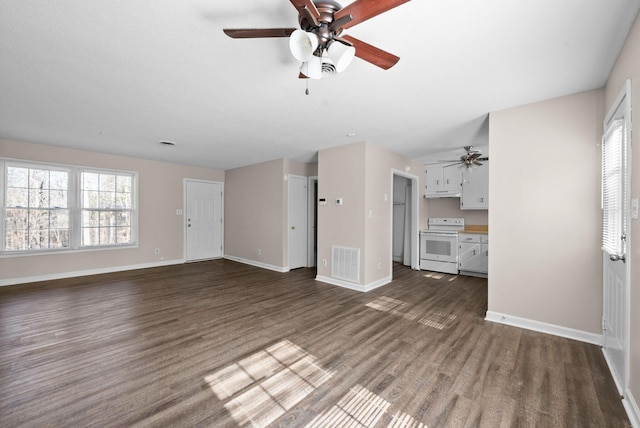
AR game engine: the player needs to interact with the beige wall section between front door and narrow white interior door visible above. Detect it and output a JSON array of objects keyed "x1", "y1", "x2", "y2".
[{"x1": 224, "y1": 159, "x2": 288, "y2": 270}]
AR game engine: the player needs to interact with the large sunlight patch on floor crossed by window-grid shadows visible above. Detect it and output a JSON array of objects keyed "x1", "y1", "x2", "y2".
[{"x1": 204, "y1": 340, "x2": 334, "y2": 426}]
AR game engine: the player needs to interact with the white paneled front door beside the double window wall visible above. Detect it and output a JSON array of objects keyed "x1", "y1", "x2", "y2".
[{"x1": 185, "y1": 180, "x2": 223, "y2": 261}]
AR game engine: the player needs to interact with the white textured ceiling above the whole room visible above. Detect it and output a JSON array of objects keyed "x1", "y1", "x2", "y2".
[{"x1": 0, "y1": 0, "x2": 640, "y2": 169}]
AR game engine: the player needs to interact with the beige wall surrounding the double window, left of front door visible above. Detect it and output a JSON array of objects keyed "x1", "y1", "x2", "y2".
[{"x1": 0, "y1": 140, "x2": 225, "y2": 283}]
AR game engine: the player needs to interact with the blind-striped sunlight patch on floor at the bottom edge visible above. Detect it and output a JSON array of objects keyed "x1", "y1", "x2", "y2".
[{"x1": 307, "y1": 385, "x2": 427, "y2": 428}]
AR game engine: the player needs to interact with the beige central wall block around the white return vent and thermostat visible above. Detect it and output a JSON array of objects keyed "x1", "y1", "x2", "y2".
[{"x1": 318, "y1": 142, "x2": 426, "y2": 287}]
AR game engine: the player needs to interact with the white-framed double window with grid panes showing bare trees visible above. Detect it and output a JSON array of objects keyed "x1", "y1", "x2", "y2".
[{"x1": 0, "y1": 159, "x2": 137, "y2": 255}]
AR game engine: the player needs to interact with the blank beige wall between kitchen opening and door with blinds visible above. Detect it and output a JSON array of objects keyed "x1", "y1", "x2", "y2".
[{"x1": 488, "y1": 90, "x2": 604, "y2": 335}]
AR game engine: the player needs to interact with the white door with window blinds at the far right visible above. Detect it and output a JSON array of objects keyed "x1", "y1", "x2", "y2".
[{"x1": 602, "y1": 82, "x2": 631, "y2": 395}]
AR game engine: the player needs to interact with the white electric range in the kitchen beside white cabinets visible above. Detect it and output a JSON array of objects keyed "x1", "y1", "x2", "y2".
[{"x1": 420, "y1": 217, "x2": 464, "y2": 274}]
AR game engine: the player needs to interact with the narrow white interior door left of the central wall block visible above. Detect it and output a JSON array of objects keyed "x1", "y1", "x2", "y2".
[{"x1": 288, "y1": 174, "x2": 308, "y2": 269}]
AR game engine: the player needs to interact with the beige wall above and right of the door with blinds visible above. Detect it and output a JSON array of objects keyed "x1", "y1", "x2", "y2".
[{"x1": 605, "y1": 10, "x2": 640, "y2": 418}]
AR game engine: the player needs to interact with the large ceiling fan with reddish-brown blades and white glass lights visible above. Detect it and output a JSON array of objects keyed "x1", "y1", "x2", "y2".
[{"x1": 223, "y1": 0, "x2": 409, "y2": 79}]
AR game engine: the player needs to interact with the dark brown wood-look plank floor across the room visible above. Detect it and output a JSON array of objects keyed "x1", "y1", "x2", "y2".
[{"x1": 0, "y1": 260, "x2": 630, "y2": 428}]
